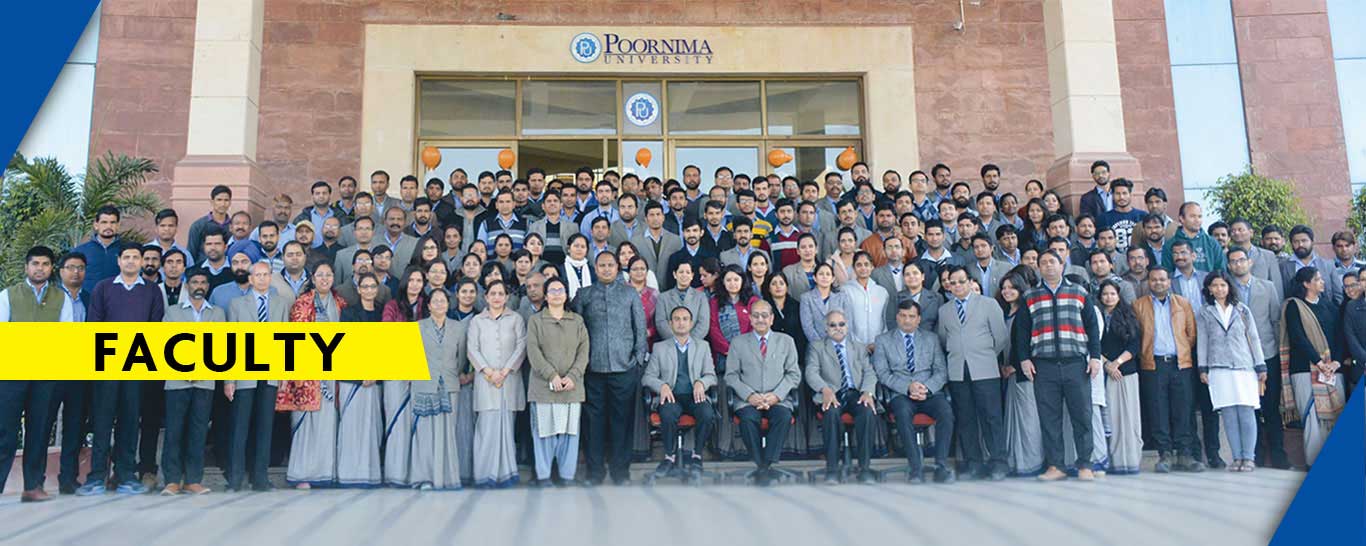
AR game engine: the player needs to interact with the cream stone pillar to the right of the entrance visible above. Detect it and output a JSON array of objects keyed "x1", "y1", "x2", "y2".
[{"x1": 1044, "y1": 0, "x2": 1142, "y2": 210}]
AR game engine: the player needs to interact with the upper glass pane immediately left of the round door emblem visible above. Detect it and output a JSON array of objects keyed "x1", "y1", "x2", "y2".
[{"x1": 522, "y1": 81, "x2": 616, "y2": 135}]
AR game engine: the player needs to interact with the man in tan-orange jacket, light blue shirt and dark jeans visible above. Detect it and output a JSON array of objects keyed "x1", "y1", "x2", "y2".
[{"x1": 1134, "y1": 263, "x2": 1205, "y2": 474}]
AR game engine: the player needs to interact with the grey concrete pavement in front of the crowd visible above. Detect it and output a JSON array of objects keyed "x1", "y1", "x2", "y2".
[{"x1": 0, "y1": 468, "x2": 1305, "y2": 546}]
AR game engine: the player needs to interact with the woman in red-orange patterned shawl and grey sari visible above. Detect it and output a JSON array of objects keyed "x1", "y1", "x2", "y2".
[{"x1": 280, "y1": 262, "x2": 346, "y2": 489}]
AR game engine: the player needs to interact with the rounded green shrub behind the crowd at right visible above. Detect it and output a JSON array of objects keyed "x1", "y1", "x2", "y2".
[{"x1": 1205, "y1": 165, "x2": 1310, "y2": 231}]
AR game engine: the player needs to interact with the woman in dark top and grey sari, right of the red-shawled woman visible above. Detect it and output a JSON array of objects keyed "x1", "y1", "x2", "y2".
[{"x1": 337, "y1": 273, "x2": 384, "y2": 487}]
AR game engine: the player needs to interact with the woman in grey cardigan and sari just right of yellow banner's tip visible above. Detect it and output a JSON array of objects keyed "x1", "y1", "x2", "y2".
[{"x1": 408, "y1": 291, "x2": 466, "y2": 490}]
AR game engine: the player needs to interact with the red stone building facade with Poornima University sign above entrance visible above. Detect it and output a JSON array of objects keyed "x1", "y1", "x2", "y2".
[{"x1": 53, "y1": 0, "x2": 1366, "y2": 229}]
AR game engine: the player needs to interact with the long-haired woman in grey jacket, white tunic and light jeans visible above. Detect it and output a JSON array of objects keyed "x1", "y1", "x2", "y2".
[{"x1": 1195, "y1": 270, "x2": 1266, "y2": 472}]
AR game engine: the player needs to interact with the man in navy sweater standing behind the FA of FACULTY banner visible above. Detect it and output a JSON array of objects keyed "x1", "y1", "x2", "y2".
[{"x1": 76, "y1": 244, "x2": 165, "y2": 497}]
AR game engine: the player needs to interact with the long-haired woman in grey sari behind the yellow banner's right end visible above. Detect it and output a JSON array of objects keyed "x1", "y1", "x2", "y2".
[{"x1": 384, "y1": 268, "x2": 426, "y2": 487}]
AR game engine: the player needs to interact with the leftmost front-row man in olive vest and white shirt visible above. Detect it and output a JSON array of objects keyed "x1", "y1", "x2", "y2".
[{"x1": 0, "y1": 246, "x2": 71, "y2": 502}]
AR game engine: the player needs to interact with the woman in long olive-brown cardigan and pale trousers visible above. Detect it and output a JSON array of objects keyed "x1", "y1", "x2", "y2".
[{"x1": 526, "y1": 278, "x2": 589, "y2": 487}]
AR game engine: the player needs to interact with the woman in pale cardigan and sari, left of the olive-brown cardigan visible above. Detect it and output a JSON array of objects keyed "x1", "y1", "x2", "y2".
[{"x1": 467, "y1": 281, "x2": 526, "y2": 487}]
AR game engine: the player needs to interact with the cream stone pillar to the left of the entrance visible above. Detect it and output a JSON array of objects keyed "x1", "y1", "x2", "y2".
[{"x1": 171, "y1": 0, "x2": 270, "y2": 233}]
